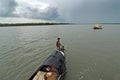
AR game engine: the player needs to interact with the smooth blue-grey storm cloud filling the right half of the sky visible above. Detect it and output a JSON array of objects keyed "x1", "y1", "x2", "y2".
[{"x1": 57, "y1": 0, "x2": 120, "y2": 23}]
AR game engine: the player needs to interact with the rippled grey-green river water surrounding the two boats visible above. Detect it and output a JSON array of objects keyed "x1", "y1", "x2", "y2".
[{"x1": 0, "y1": 24, "x2": 120, "y2": 80}]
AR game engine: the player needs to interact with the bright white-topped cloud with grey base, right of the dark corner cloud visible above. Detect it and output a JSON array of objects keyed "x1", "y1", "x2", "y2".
[{"x1": 14, "y1": 0, "x2": 59, "y2": 20}]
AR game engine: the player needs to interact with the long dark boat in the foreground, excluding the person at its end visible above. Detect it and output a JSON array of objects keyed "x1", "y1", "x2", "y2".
[{"x1": 29, "y1": 51, "x2": 66, "y2": 80}]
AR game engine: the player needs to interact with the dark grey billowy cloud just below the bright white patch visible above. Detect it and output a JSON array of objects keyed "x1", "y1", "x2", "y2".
[{"x1": 16, "y1": 6, "x2": 59, "y2": 20}]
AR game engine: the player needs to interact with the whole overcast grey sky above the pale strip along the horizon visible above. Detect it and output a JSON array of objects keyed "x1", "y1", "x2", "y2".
[{"x1": 0, "y1": 0, "x2": 120, "y2": 23}]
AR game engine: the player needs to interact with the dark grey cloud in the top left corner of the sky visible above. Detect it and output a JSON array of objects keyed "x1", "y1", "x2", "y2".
[{"x1": 0, "y1": 0, "x2": 17, "y2": 17}]
